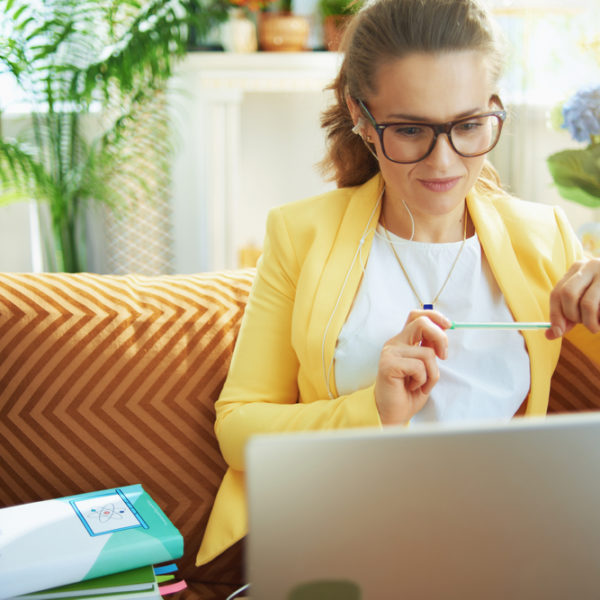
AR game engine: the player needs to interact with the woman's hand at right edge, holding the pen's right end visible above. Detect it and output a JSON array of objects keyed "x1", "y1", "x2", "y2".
[{"x1": 546, "y1": 258, "x2": 600, "y2": 340}]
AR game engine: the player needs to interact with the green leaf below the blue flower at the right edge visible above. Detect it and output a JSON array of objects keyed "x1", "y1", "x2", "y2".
[{"x1": 547, "y1": 144, "x2": 600, "y2": 207}]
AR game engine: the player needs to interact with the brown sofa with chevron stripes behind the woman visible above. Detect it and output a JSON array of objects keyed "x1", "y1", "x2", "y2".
[{"x1": 0, "y1": 269, "x2": 600, "y2": 600}]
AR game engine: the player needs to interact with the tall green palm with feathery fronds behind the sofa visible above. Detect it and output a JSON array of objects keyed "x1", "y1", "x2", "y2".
[{"x1": 0, "y1": 0, "x2": 226, "y2": 272}]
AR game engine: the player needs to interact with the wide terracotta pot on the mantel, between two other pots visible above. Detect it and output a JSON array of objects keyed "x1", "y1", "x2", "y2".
[{"x1": 258, "y1": 12, "x2": 310, "y2": 52}]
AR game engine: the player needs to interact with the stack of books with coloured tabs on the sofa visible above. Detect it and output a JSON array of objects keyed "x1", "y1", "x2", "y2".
[{"x1": 0, "y1": 484, "x2": 186, "y2": 600}]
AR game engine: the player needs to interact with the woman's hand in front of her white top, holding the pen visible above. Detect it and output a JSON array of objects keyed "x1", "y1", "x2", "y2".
[{"x1": 375, "y1": 310, "x2": 452, "y2": 425}]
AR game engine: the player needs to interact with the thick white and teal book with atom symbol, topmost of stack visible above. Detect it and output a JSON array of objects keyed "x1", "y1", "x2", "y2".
[{"x1": 0, "y1": 484, "x2": 183, "y2": 600}]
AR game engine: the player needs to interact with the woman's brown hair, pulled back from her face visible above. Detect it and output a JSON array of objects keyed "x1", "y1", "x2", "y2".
[{"x1": 321, "y1": 0, "x2": 504, "y2": 189}]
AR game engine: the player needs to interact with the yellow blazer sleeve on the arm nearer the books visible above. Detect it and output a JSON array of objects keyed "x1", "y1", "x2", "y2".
[{"x1": 215, "y1": 209, "x2": 381, "y2": 470}]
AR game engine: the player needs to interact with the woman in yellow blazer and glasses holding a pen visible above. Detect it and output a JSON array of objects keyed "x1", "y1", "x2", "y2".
[{"x1": 198, "y1": 0, "x2": 600, "y2": 563}]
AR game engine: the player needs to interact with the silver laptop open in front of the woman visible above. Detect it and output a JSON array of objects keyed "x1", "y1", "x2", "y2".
[{"x1": 247, "y1": 413, "x2": 600, "y2": 600}]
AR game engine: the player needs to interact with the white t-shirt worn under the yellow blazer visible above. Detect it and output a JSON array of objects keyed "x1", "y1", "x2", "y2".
[{"x1": 334, "y1": 225, "x2": 530, "y2": 422}]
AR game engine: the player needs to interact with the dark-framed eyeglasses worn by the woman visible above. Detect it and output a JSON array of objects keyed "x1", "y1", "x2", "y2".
[{"x1": 355, "y1": 99, "x2": 506, "y2": 165}]
